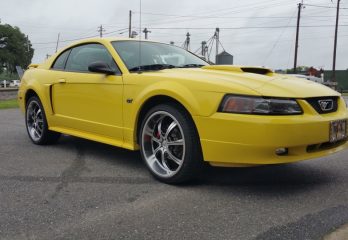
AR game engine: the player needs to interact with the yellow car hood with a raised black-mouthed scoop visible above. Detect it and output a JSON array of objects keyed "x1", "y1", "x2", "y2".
[{"x1": 145, "y1": 65, "x2": 340, "y2": 98}]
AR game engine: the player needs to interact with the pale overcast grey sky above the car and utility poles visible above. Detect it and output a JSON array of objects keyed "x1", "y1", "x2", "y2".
[{"x1": 0, "y1": 0, "x2": 348, "y2": 70}]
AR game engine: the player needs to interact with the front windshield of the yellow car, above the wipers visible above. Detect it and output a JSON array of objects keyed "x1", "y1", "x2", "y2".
[{"x1": 112, "y1": 41, "x2": 208, "y2": 71}]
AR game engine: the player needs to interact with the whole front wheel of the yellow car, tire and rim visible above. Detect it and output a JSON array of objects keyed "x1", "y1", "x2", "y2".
[{"x1": 139, "y1": 104, "x2": 202, "y2": 183}]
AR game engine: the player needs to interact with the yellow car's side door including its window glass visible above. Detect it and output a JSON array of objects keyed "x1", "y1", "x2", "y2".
[{"x1": 52, "y1": 43, "x2": 123, "y2": 145}]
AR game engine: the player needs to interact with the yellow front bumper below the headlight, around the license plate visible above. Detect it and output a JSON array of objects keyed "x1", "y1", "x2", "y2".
[{"x1": 194, "y1": 99, "x2": 348, "y2": 166}]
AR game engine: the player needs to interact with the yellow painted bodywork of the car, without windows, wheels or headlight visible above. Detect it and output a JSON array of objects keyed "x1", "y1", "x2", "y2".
[{"x1": 18, "y1": 38, "x2": 348, "y2": 166}]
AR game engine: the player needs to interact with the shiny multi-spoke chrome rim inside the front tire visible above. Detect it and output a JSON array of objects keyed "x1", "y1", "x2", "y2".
[{"x1": 141, "y1": 111, "x2": 185, "y2": 177}]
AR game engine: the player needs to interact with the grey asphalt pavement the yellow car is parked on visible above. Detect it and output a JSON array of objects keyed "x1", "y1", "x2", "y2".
[{"x1": 0, "y1": 109, "x2": 348, "y2": 240}]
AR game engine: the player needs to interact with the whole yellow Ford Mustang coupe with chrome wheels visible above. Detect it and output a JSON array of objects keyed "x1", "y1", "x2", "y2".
[{"x1": 18, "y1": 38, "x2": 348, "y2": 183}]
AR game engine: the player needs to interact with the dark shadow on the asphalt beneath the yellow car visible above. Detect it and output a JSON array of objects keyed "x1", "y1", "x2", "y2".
[{"x1": 57, "y1": 136, "x2": 339, "y2": 194}]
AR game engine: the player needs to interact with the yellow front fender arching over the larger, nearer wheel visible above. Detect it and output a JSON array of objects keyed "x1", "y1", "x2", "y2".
[{"x1": 123, "y1": 78, "x2": 223, "y2": 148}]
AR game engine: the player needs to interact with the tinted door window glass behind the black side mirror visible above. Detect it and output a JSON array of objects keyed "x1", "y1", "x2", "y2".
[{"x1": 65, "y1": 43, "x2": 120, "y2": 73}]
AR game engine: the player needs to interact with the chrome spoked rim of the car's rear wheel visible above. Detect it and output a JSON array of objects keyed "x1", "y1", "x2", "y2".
[{"x1": 26, "y1": 101, "x2": 44, "y2": 142}]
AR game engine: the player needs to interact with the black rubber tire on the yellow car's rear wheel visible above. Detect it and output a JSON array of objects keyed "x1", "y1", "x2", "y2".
[{"x1": 25, "y1": 96, "x2": 61, "y2": 145}]
